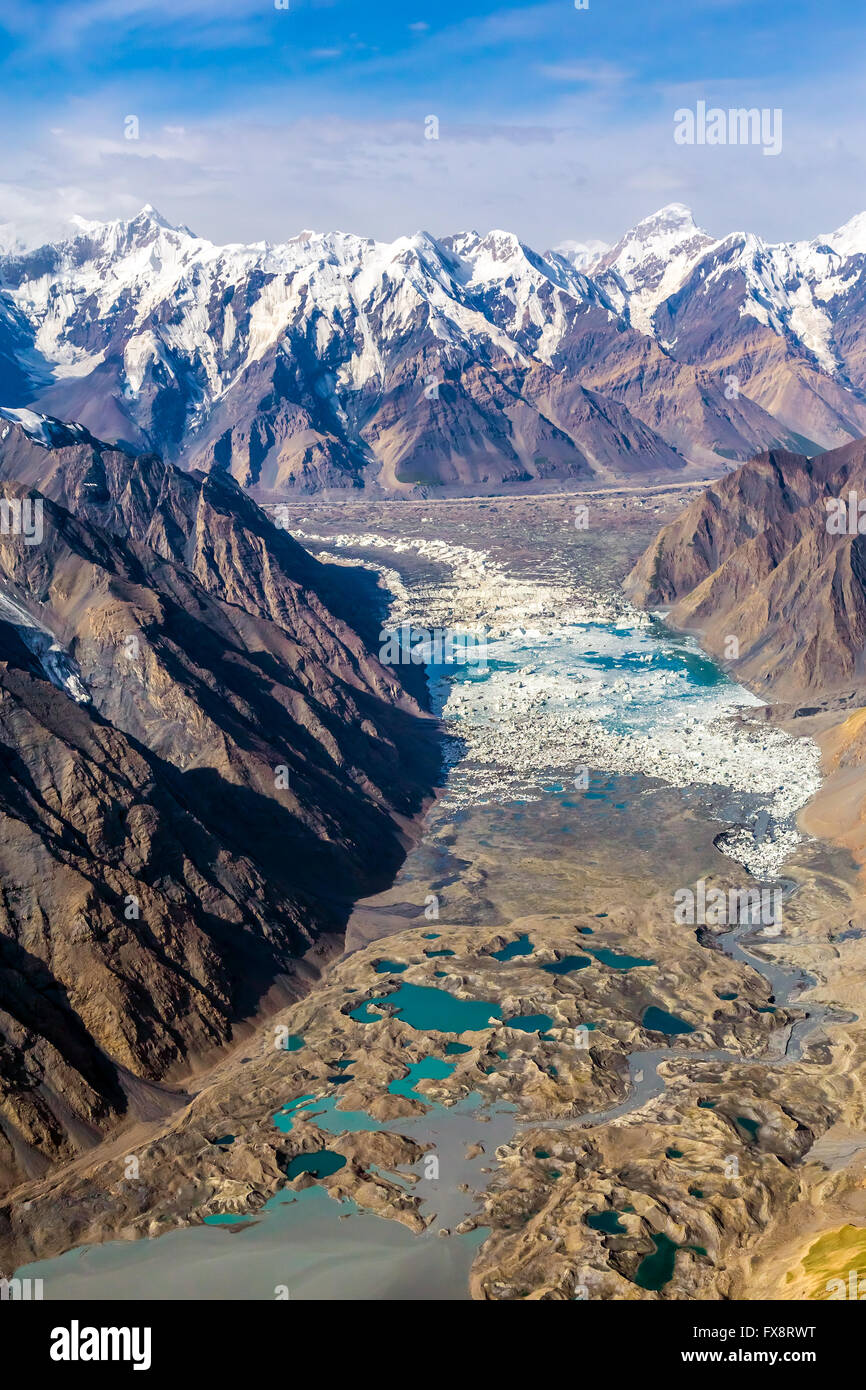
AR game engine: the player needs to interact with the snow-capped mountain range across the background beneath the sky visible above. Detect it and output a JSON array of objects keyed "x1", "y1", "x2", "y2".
[{"x1": 0, "y1": 203, "x2": 866, "y2": 502}]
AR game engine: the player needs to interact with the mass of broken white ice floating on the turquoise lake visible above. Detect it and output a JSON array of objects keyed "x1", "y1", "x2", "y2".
[{"x1": 295, "y1": 530, "x2": 820, "y2": 877}]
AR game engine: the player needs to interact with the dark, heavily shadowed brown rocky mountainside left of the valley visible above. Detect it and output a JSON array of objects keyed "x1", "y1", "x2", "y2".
[{"x1": 0, "y1": 425, "x2": 439, "y2": 1186}]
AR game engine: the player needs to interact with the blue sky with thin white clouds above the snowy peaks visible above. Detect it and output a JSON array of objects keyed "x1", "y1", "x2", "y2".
[{"x1": 0, "y1": 0, "x2": 866, "y2": 249}]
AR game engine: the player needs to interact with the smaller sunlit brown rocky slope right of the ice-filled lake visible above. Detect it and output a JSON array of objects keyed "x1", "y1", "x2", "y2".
[{"x1": 626, "y1": 441, "x2": 866, "y2": 701}]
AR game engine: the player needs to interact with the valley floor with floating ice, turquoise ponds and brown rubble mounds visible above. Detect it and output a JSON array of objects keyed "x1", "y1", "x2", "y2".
[{"x1": 6, "y1": 488, "x2": 866, "y2": 1300}]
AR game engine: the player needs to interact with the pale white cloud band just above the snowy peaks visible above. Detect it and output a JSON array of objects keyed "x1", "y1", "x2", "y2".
[{"x1": 0, "y1": 51, "x2": 866, "y2": 250}]
